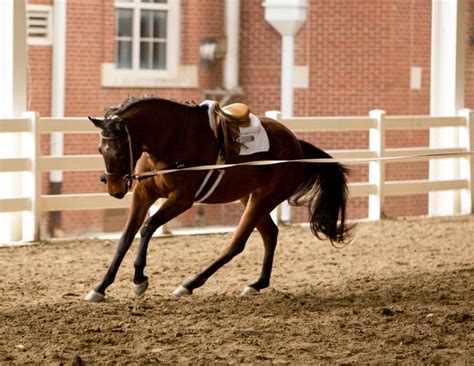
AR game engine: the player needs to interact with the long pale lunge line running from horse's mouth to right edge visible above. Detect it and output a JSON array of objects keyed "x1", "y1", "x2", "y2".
[{"x1": 132, "y1": 151, "x2": 474, "y2": 181}]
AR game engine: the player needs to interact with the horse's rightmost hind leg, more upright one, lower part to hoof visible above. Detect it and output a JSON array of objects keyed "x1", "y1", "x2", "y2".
[{"x1": 242, "y1": 215, "x2": 278, "y2": 295}]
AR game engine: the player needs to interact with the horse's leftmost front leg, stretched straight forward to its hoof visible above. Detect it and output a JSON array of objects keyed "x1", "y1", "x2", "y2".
[{"x1": 85, "y1": 185, "x2": 157, "y2": 302}]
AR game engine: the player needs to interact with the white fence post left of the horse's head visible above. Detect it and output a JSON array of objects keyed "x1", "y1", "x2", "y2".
[{"x1": 22, "y1": 112, "x2": 41, "y2": 241}]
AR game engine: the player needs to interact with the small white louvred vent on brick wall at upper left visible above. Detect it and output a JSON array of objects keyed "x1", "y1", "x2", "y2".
[{"x1": 27, "y1": 5, "x2": 52, "y2": 46}]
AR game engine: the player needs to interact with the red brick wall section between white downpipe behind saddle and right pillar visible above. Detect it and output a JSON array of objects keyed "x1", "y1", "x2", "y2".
[{"x1": 241, "y1": 0, "x2": 431, "y2": 219}]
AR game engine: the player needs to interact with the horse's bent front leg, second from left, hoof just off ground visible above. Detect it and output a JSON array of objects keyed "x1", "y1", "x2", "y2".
[{"x1": 133, "y1": 194, "x2": 194, "y2": 296}]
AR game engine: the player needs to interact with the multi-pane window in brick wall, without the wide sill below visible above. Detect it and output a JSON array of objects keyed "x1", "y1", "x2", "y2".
[{"x1": 115, "y1": 0, "x2": 179, "y2": 72}]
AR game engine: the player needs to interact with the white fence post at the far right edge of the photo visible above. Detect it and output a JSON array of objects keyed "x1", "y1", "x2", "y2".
[{"x1": 459, "y1": 108, "x2": 474, "y2": 215}]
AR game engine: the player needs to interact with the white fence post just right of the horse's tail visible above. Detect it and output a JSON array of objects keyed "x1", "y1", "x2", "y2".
[{"x1": 368, "y1": 109, "x2": 385, "y2": 220}]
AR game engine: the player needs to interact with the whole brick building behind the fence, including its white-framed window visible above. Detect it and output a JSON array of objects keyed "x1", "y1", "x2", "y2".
[{"x1": 28, "y1": 0, "x2": 474, "y2": 233}]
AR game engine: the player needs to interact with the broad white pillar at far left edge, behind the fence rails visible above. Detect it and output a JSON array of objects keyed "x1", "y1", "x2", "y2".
[{"x1": 0, "y1": 0, "x2": 28, "y2": 242}]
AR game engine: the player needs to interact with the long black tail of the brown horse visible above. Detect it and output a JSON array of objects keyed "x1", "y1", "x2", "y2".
[{"x1": 289, "y1": 140, "x2": 352, "y2": 244}]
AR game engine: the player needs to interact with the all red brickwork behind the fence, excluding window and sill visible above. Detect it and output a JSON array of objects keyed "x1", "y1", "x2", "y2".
[{"x1": 25, "y1": 0, "x2": 474, "y2": 232}]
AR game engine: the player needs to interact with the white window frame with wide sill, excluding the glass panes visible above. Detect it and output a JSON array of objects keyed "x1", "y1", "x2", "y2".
[{"x1": 102, "y1": 0, "x2": 198, "y2": 88}]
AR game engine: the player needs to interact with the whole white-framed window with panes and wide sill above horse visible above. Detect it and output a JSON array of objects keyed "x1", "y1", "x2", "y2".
[{"x1": 103, "y1": 0, "x2": 199, "y2": 88}]
